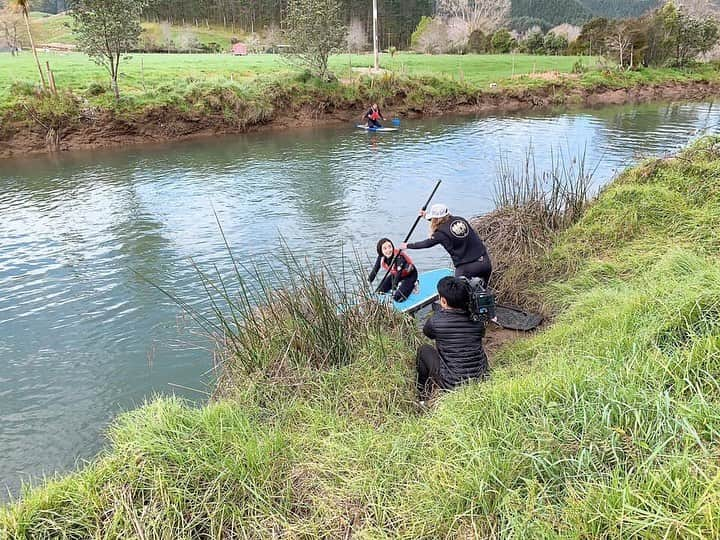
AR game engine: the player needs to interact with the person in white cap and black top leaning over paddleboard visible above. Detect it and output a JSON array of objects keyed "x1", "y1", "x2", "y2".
[{"x1": 400, "y1": 204, "x2": 492, "y2": 287}]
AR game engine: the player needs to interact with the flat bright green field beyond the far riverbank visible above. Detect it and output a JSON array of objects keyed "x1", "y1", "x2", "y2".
[{"x1": 0, "y1": 52, "x2": 594, "y2": 97}]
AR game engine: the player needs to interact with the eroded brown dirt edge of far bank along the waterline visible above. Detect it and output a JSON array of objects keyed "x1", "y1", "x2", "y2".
[{"x1": 0, "y1": 81, "x2": 720, "y2": 158}]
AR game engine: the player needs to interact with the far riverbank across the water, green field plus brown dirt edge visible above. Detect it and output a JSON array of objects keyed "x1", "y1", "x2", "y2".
[{"x1": 0, "y1": 50, "x2": 720, "y2": 157}]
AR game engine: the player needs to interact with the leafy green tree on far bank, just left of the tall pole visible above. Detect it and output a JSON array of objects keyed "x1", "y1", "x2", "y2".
[{"x1": 284, "y1": 0, "x2": 346, "y2": 80}]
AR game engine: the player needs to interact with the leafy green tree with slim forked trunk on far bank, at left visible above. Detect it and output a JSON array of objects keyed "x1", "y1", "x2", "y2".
[{"x1": 70, "y1": 0, "x2": 147, "y2": 99}]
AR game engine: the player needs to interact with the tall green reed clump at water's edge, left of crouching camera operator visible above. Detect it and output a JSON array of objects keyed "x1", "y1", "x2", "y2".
[{"x1": 172, "y1": 240, "x2": 415, "y2": 395}]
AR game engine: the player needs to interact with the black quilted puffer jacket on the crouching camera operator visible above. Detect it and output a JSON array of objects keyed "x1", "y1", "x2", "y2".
[{"x1": 423, "y1": 308, "x2": 489, "y2": 389}]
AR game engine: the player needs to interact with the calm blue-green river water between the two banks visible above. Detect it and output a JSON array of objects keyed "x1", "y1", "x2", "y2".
[{"x1": 0, "y1": 103, "x2": 720, "y2": 498}]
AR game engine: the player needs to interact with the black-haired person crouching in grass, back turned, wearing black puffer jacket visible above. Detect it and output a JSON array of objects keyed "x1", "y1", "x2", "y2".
[{"x1": 417, "y1": 276, "x2": 489, "y2": 403}]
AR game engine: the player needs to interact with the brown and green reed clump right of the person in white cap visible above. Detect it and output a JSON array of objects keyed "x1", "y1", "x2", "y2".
[{"x1": 473, "y1": 147, "x2": 595, "y2": 308}]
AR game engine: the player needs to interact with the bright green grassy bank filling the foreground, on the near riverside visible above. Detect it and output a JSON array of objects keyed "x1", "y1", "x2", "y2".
[{"x1": 0, "y1": 138, "x2": 720, "y2": 539}]
